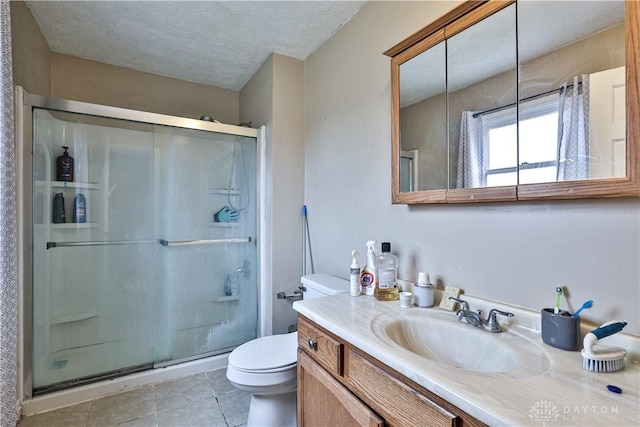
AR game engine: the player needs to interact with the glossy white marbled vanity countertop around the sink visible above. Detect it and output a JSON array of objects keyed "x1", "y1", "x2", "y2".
[{"x1": 293, "y1": 293, "x2": 640, "y2": 426}]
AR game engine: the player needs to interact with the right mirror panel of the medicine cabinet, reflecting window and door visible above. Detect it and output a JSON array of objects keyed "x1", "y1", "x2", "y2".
[{"x1": 518, "y1": 1, "x2": 626, "y2": 184}]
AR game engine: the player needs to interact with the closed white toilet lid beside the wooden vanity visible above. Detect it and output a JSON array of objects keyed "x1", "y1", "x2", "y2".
[{"x1": 229, "y1": 332, "x2": 298, "y2": 371}]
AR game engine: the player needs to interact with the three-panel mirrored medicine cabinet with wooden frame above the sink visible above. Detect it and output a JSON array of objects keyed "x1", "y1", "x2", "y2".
[{"x1": 384, "y1": 0, "x2": 640, "y2": 204}]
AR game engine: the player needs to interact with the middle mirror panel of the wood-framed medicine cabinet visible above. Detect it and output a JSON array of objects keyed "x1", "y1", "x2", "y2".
[{"x1": 448, "y1": 4, "x2": 518, "y2": 188}]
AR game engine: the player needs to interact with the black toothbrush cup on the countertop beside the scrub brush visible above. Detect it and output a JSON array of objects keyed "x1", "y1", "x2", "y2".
[{"x1": 541, "y1": 308, "x2": 581, "y2": 351}]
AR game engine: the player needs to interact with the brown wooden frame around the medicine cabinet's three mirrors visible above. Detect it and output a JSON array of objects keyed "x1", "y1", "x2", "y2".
[{"x1": 384, "y1": 0, "x2": 640, "y2": 204}]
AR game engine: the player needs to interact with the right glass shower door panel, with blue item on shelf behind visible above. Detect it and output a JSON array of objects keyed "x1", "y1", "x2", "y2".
[{"x1": 155, "y1": 126, "x2": 258, "y2": 365}]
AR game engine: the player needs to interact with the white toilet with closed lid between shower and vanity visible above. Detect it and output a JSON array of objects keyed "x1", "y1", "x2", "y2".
[{"x1": 227, "y1": 274, "x2": 349, "y2": 427}]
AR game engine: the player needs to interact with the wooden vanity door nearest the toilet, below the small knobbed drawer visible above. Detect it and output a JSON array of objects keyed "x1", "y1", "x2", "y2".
[{"x1": 298, "y1": 350, "x2": 384, "y2": 427}]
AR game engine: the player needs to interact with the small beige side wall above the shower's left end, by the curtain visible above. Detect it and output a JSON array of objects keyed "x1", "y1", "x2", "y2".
[{"x1": 10, "y1": 1, "x2": 51, "y2": 96}]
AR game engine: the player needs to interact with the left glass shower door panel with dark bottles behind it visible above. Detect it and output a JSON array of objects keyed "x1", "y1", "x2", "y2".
[{"x1": 32, "y1": 109, "x2": 160, "y2": 391}]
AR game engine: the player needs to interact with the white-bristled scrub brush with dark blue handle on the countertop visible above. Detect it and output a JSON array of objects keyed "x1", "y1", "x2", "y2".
[{"x1": 582, "y1": 322, "x2": 627, "y2": 372}]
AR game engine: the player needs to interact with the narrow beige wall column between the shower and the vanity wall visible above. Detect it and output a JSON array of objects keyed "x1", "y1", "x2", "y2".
[{"x1": 240, "y1": 54, "x2": 305, "y2": 333}]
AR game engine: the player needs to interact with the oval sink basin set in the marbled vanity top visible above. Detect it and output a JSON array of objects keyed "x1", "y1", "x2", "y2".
[{"x1": 371, "y1": 309, "x2": 550, "y2": 377}]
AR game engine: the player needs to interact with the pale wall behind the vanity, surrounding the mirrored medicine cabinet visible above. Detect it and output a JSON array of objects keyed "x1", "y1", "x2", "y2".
[{"x1": 305, "y1": 1, "x2": 640, "y2": 334}]
